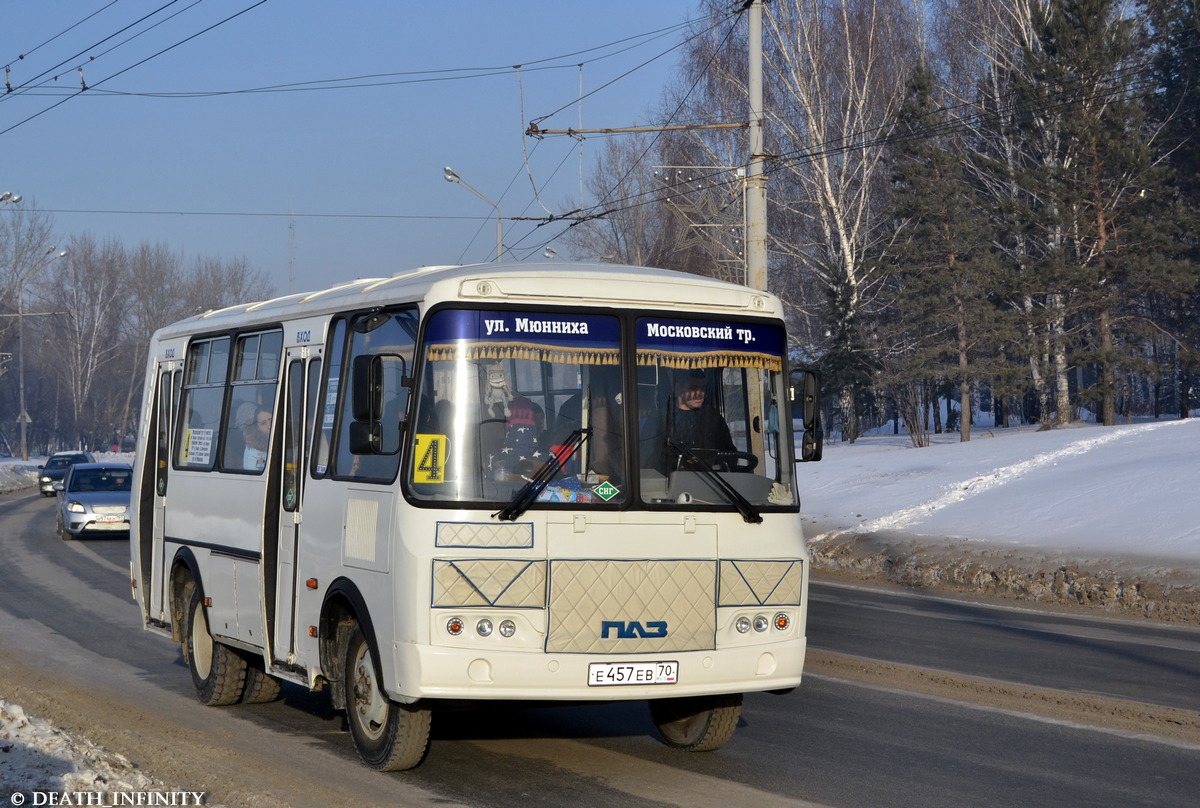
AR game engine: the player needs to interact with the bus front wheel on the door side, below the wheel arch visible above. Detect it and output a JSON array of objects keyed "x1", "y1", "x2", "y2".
[{"x1": 343, "y1": 621, "x2": 431, "y2": 772}]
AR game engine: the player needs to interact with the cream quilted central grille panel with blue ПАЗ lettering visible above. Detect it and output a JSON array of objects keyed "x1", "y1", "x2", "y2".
[{"x1": 546, "y1": 559, "x2": 716, "y2": 653}]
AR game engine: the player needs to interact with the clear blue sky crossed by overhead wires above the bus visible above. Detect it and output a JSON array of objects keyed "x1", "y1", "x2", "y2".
[{"x1": 0, "y1": 0, "x2": 698, "y2": 293}]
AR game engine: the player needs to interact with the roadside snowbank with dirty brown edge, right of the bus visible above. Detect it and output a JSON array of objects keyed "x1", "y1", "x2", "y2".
[{"x1": 799, "y1": 418, "x2": 1200, "y2": 622}]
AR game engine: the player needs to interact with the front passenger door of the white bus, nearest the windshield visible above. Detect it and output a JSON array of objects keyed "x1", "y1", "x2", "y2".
[{"x1": 271, "y1": 346, "x2": 320, "y2": 664}]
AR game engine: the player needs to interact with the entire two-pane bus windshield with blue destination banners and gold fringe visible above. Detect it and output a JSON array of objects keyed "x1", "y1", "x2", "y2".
[{"x1": 407, "y1": 309, "x2": 796, "y2": 506}]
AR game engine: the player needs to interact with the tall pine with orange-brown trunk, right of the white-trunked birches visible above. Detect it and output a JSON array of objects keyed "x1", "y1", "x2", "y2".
[{"x1": 1015, "y1": 0, "x2": 1163, "y2": 424}]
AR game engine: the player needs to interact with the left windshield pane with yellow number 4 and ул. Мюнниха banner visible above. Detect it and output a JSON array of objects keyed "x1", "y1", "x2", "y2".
[{"x1": 409, "y1": 310, "x2": 626, "y2": 505}]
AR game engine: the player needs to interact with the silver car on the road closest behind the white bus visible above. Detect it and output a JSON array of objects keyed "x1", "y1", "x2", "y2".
[{"x1": 54, "y1": 463, "x2": 133, "y2": 540}]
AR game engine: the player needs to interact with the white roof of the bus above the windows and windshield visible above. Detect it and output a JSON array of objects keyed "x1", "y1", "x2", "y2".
[{"x1": 158, "y1": 262, "x2": 782, "y2": 339}]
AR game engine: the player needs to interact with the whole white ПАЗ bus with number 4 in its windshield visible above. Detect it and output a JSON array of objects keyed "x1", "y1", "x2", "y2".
[{"x1": 131, "y1": 263, "x2": 821, "y2": 770}]
